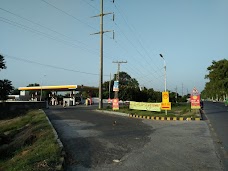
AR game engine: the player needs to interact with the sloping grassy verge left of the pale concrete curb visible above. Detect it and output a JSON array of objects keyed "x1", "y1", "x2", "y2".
[{"x1": 0, "y1": 110, "x2": 61, "y2": 171}]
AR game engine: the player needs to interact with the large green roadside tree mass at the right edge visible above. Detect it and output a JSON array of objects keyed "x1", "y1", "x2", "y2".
[{"x1": 202, "y1": 59, "x2": 228, "y2": 99}]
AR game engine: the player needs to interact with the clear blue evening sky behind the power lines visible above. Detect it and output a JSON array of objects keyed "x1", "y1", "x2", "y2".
[{"x1": 0, "y1": 0, "x2": 228, "y2": 95}]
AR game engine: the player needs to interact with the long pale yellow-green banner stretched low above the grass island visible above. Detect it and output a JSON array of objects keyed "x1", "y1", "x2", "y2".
[{"x1": 129, "y1": 101, "x2": 161, "y2": 112}]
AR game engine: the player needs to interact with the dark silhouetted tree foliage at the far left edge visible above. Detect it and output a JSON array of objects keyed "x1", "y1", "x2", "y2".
[{"x1": 0, "y1": 54, "x2": 14, "y2": 100}]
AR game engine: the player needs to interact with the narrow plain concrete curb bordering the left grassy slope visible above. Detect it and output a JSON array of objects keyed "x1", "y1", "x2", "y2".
[{"x1": 43, "y1": 111, "x2": 66, "y2": 171}]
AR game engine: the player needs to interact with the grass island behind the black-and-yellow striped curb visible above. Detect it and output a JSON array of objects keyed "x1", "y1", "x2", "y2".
[{"x1": 105, "y1": 103, "x2": 199, "y2": 118}]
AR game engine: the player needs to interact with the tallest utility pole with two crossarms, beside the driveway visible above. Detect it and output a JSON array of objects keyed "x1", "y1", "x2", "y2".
[{"x1": 93, "y1": 0, "x2": 114, "y2": 109}]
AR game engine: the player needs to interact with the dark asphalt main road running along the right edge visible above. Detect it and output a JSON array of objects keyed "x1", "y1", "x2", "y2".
[{"x1": 204, "y1": 102, "x2": 228, "y2": 170}]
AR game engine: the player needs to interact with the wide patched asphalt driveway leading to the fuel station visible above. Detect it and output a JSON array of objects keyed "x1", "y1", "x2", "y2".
[{"x1": 45, "y1": 106, "x2": 223, "y2": 171}]
